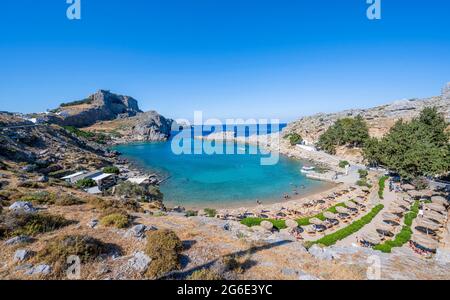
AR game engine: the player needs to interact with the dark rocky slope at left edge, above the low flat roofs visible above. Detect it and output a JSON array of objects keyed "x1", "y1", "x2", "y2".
[{"x1": 0, "y1": 114, "x2": 109, "y2": 174}]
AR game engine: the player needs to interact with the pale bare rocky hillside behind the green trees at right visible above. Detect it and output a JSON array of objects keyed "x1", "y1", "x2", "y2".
[{"x1": 285, "y1": 83, "x2": 450, "y2": 143}]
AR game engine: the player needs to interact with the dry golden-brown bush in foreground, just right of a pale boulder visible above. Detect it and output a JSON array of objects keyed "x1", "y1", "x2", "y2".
[{"x1": 145, "y1": 230, "x2": 183, "y2": 279}]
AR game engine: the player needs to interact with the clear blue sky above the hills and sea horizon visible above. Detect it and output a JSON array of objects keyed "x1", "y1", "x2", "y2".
[{"x1": 0, "y1": 0, "x2": 450, "y2": 121}]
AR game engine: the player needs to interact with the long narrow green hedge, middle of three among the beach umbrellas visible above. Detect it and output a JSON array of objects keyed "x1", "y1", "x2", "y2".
[{"x1": 306, "y1": 204, "x2": 384, "y2": 248}]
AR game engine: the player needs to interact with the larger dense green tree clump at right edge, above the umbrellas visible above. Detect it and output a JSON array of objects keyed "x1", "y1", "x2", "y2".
[{"x1": 363, "y1": 108, "x2": 450, "y2": 179}]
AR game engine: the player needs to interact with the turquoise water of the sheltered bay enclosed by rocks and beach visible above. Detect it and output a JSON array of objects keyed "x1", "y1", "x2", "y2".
[{"x1": 115, "y1": 126, "x2": 325, "y2": 208}]
